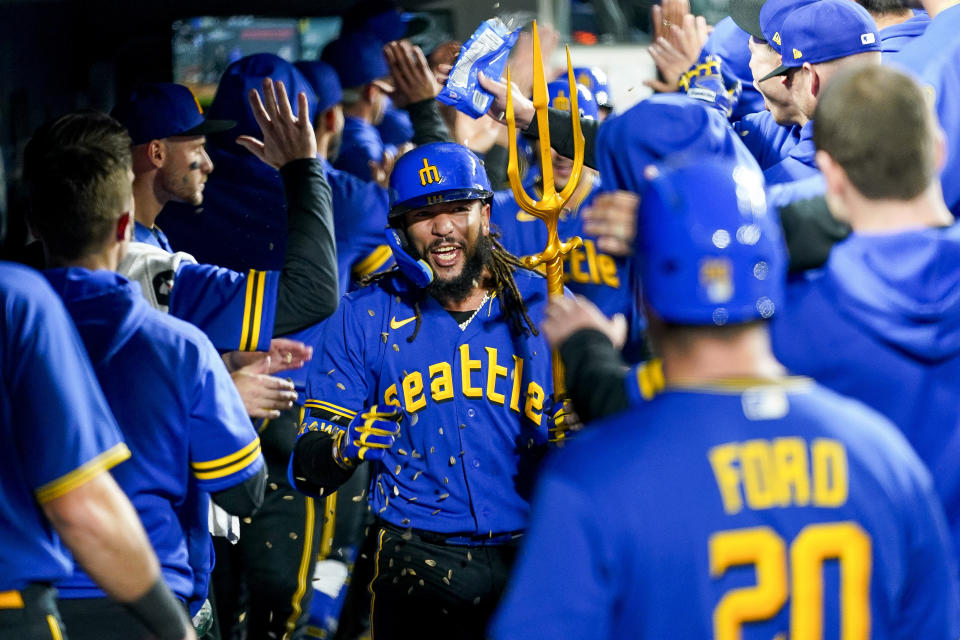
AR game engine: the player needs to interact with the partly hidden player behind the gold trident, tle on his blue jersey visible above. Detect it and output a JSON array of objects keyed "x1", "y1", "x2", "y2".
[{"x1": 490, "y1": 80, "x2": 643, "y2": 360}]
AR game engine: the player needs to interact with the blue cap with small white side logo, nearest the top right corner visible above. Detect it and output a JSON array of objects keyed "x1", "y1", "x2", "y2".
[{"x1": 760, "y1": 0, "x2": 881, "y2": 82}]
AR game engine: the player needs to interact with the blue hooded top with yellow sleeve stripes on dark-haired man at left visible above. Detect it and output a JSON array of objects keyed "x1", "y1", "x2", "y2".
[{"x1": 45, "y1": 268, "x2": 263, "y2": 602}]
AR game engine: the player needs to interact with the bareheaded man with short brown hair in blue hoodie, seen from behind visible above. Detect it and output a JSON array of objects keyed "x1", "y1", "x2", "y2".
[{"x1": 773, "y1": 68, "x2": 960, "y2": 580}]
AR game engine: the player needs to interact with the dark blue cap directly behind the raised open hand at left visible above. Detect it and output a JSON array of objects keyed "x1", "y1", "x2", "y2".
[{"x1": 210, "y1": 53, "x2": 317, "y2": 147}]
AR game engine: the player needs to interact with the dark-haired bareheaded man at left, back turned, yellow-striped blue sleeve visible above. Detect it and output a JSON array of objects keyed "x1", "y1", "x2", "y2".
[{"x1": 23, "y1": 136, "x2": 266, "y2": 639}]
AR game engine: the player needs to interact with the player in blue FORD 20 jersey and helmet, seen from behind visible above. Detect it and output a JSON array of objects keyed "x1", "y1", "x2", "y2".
[{"x1": 491, "y1": 160, "x2": 960, "y2": 640}]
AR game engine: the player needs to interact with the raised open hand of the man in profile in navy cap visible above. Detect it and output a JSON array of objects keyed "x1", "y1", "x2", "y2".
[{"x1": 237, "y1": 78, "x2": 317, "y2": 169}]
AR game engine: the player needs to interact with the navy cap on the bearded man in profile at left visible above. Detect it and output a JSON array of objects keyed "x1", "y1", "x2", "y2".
[{"x1": 110, "y1": 82, "x2": 237, "y2": 145}]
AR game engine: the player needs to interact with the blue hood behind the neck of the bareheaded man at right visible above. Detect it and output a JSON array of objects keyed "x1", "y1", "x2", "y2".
[{"x1": 824, "y1": 225, "x2": 960, "y2": 362}]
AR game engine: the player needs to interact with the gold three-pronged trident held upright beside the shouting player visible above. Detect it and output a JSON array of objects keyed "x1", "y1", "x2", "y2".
[{"x1": 507, "y1": 21, "x2": 584, "y2": 440}]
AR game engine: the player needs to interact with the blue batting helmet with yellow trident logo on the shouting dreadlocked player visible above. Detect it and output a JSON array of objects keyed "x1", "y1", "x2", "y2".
[{"x1": 390, "y1": 142, "x2": 493, "y2": 218}]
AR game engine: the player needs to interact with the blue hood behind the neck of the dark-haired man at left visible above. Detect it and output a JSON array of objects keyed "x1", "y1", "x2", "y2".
[{"x1": 43, "y1": 267, "x2": 148, "y2": 366}]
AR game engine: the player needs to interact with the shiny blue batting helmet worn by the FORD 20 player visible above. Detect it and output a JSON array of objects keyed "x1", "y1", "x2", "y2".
[{"x1": 636, "y1": 159, "x2": 786, "y2": 326}]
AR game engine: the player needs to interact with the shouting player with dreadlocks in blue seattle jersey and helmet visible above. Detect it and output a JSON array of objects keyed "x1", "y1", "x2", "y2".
[{"x1": 290, "y1": 142, "x2": 553, "y2": 640}]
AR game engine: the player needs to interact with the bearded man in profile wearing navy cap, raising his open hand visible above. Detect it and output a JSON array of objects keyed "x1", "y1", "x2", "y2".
[{"x1": 113, "y1": 81, "x2": 336, "y2": 351}]
